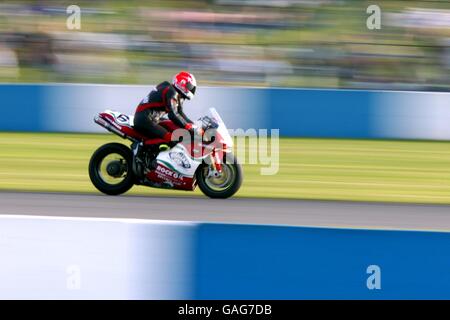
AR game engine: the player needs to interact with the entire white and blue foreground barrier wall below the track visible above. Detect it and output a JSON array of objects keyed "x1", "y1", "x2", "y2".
[{"x1": 0, "y1": 215, "x2": 450, "y2": 299}]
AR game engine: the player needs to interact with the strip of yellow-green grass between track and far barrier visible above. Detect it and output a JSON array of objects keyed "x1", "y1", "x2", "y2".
[{"x1": 0, "y1": 133, "x2": 450, "y2": 203}]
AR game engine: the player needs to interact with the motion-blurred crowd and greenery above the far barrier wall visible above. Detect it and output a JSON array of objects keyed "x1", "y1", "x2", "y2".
[{"x1": 0, "y1": 0, "x2": 450, "y2": 91}]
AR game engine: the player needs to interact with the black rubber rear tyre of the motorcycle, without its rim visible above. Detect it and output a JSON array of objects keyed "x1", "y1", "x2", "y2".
[{"x1": 89, "y1": 143, "x2": 134, "y2": 195}]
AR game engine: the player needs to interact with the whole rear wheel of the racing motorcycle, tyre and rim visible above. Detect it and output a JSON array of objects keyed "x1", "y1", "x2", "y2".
[{"x1": 89, "y1": 143, "x2": 134, "y2": 195}]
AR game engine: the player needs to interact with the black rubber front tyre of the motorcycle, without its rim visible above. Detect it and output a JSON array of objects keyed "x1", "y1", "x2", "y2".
[{"x1": 196, "y1": 153, "x2": 243, "y2": 199}]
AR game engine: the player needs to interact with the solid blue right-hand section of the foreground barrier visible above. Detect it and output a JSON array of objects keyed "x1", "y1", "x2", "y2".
[{"x1": 195, "y1": 224, "x2": 450, "y2": 299}]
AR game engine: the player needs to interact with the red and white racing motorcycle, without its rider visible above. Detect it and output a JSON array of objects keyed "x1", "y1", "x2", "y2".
[{"x1": 89, "y1": 108, "x2": 243, "y2": 198}]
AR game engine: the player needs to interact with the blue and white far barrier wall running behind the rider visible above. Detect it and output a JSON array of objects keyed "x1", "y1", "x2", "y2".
[{"x1": 0, "y1": 84, "x2": 450, "y2": 140}]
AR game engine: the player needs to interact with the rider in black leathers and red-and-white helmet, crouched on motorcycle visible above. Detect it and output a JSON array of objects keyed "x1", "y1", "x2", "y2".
[{"x1": 134, "y1": 71, "x2": 202, "y2": 150}]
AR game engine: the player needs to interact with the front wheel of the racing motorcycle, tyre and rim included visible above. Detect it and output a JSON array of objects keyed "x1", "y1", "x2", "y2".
[{"x1": 197, "y1": 153, "x2": 243, "y2": 199}]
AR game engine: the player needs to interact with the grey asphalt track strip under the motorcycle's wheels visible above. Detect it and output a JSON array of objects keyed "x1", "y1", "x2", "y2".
[{"x1": 0, "y1": 192, "x2": 450, "y2": 231}]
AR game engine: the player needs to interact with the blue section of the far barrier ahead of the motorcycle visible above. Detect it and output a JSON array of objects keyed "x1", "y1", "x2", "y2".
[{"x1": 267, "y1": 89, "x2": 376, "y2": 138}]
